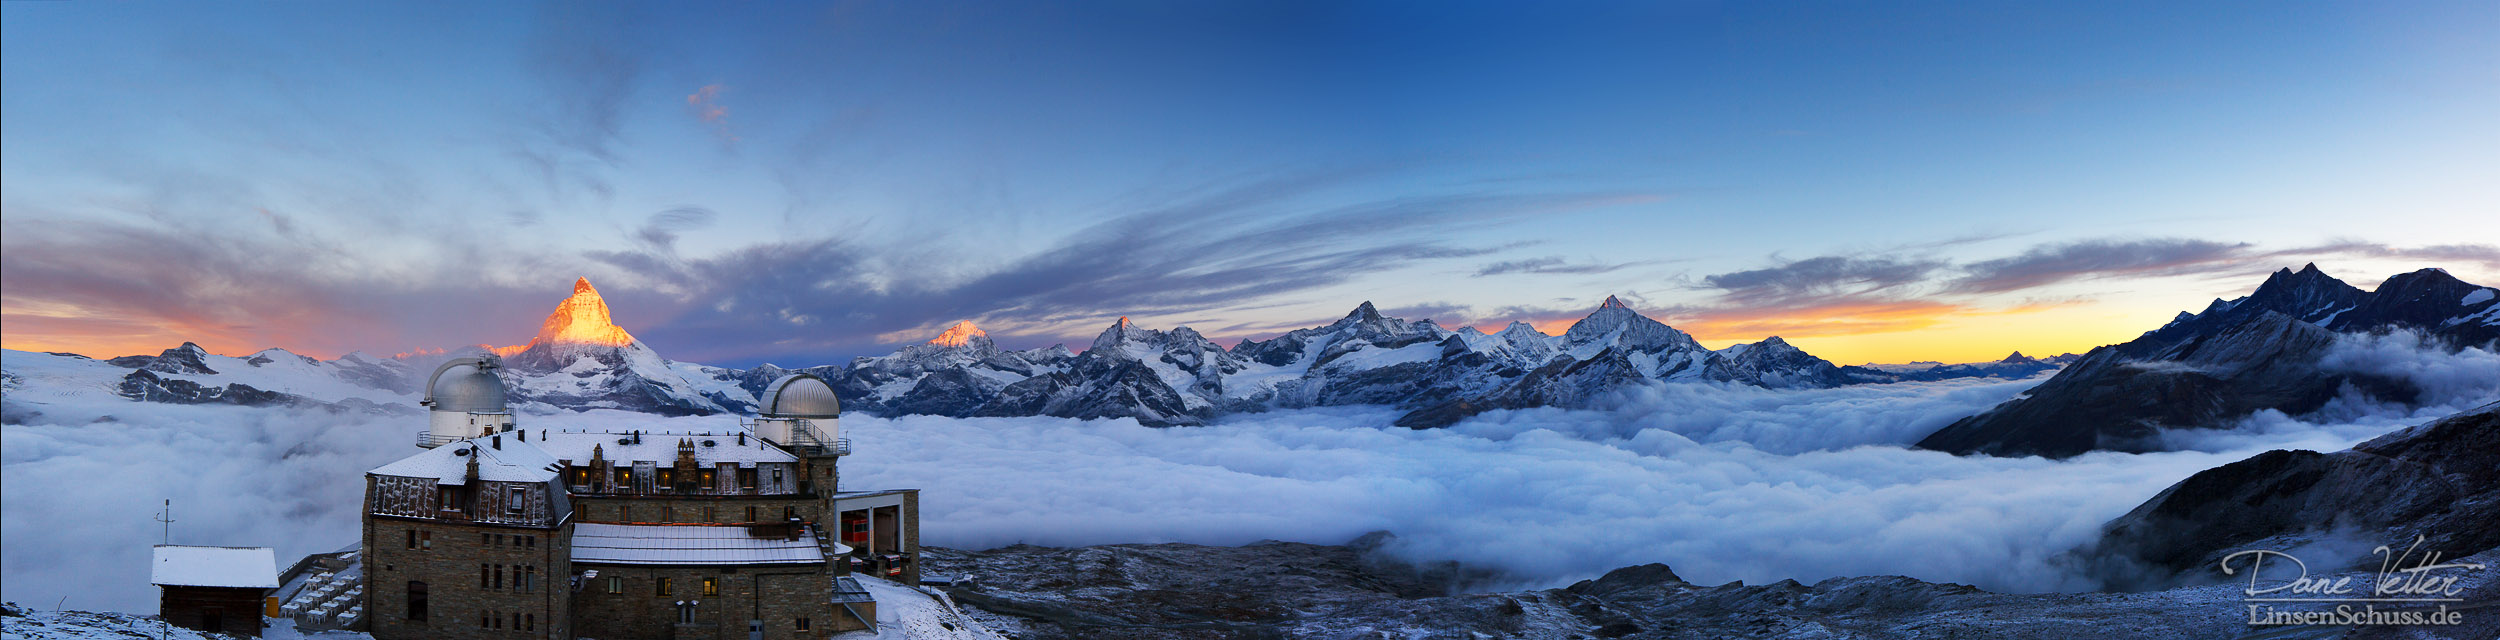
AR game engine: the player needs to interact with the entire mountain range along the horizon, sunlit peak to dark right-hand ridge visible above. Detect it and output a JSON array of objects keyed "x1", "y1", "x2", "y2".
[{"x1": 0, "y1": 265, "x2": 2500, "y2": 458}]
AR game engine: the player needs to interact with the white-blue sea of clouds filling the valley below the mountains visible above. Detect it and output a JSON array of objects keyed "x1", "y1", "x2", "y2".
[{"x1": 0, "y1": 338, "x2": 2500, "y2": 613}]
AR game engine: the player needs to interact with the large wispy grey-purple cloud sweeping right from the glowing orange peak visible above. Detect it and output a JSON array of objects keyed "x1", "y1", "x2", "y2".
[{"x1": 590, "y1": 188, "x2": 1605, "y2": 360}]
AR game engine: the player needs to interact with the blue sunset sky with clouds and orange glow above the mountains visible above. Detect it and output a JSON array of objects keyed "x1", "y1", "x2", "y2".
[{"x1": 0, "y1": 3, "x2": 2500, "y2": 365}]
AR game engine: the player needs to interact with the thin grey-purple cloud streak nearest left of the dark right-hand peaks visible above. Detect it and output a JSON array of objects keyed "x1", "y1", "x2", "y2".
[{"x1": 1950, "y1": 238, "x2": 2250, "y2": 293}]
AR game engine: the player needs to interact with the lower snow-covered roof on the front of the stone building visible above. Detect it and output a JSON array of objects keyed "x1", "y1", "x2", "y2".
[{"x1": 573, "y1": 523, "x2": 825, "y2": 565}]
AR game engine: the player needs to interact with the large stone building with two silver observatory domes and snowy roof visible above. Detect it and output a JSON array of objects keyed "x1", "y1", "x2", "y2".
[{"x1": 363, "y1": 358, "x2": 920, "y2": 640}]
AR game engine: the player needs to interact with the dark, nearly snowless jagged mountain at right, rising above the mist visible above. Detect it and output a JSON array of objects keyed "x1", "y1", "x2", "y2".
[{"x1": 1918, "y1": 265, "x2": 2500, "y2": 458}]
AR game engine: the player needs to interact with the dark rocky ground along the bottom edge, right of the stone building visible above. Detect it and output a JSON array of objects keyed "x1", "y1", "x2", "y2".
[{"x1": 928, "y1": 538, "x2": 2500, "y2": 640}]
